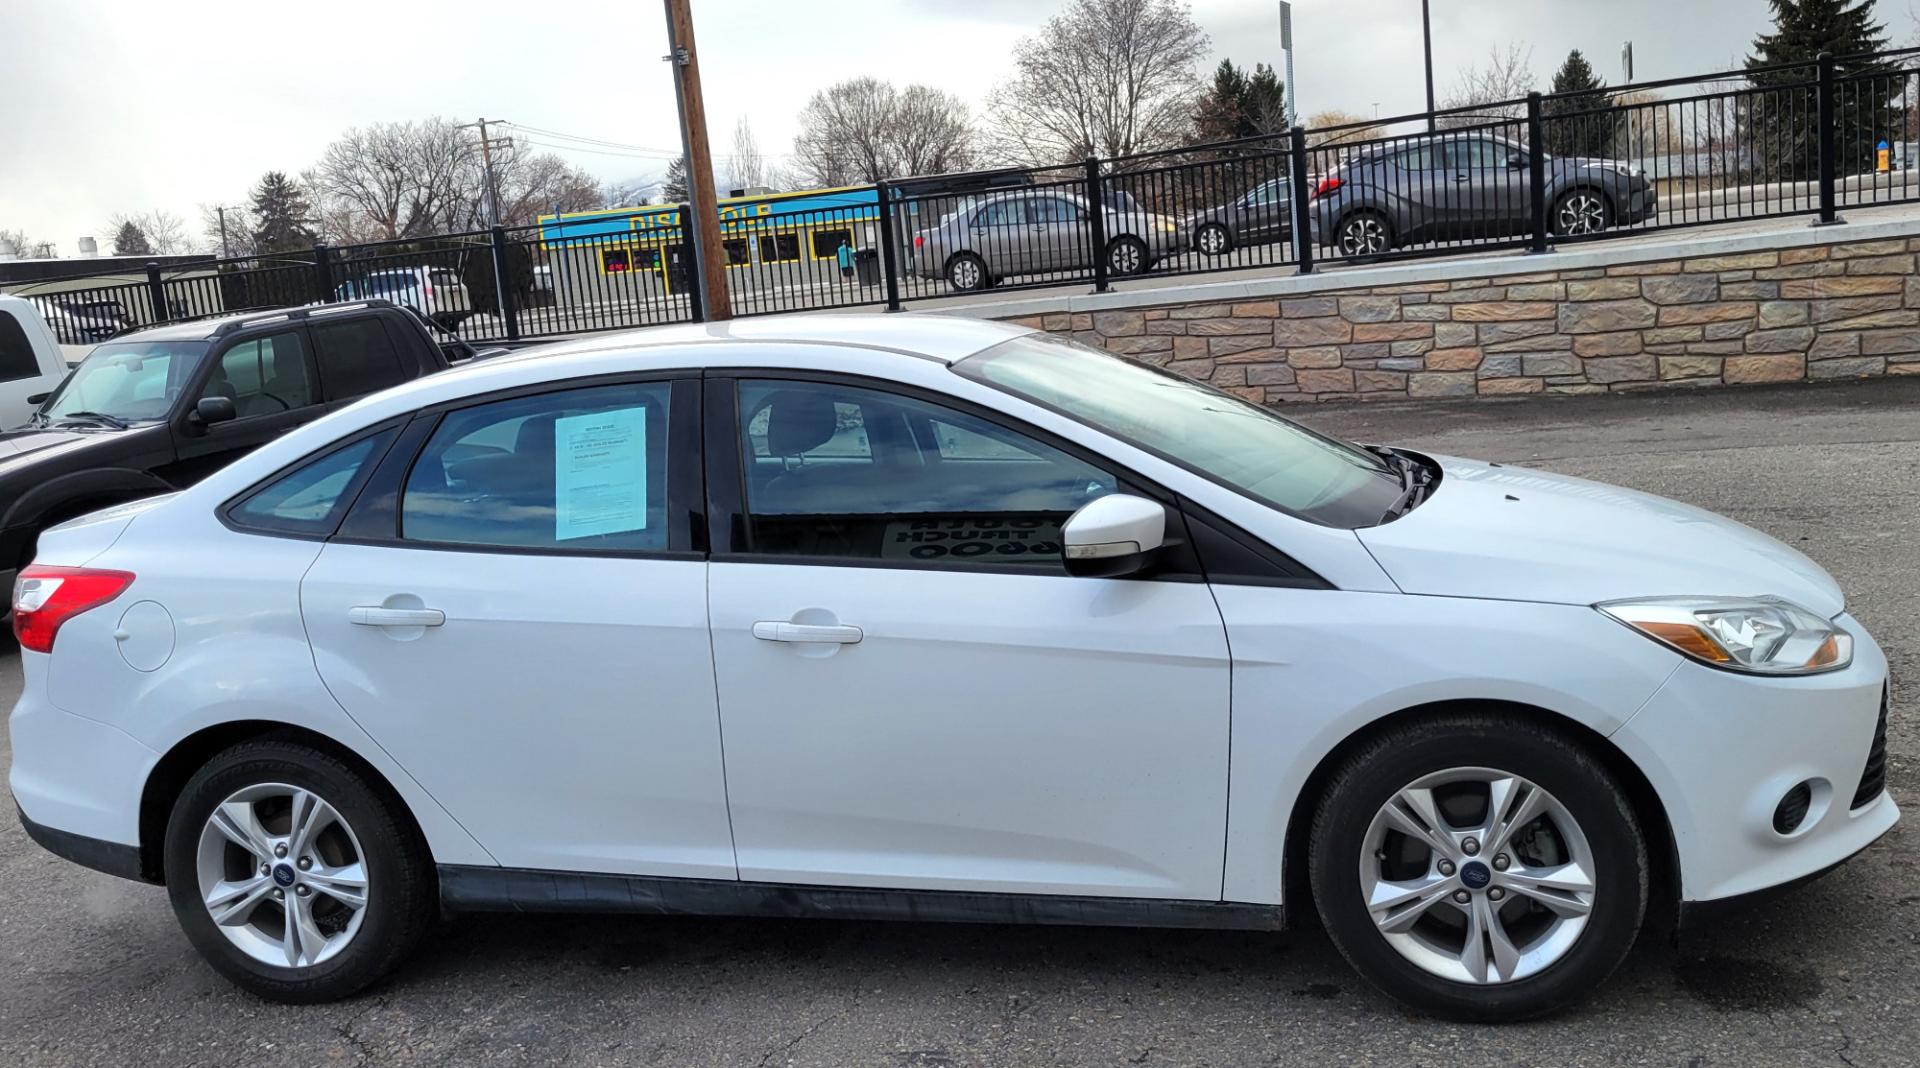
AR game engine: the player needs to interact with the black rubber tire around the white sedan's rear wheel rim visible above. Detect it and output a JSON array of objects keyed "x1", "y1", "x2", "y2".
[{"x1": 165, "y1": 740, "x2": 440, "y2": 1005}]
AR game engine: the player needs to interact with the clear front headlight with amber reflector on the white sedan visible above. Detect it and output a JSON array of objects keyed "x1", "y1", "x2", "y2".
[{"x1": 1594, "y1": 597, "x2": 1853, "y2": 674}]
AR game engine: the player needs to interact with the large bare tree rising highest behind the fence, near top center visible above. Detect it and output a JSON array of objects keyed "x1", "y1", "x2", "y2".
[{"x1": 987, "y1": 0, "x2": 1208, "y2": 165}]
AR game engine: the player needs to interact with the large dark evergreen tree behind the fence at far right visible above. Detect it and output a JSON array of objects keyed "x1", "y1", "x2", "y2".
[{"x1": 1736, "y1": 0, "x2": 1903, "y2": 181}]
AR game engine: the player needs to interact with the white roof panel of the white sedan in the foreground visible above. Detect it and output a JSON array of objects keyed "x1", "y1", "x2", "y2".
[{"x1": 474, "y1": 313, "x2": 1033, "y2": 369}]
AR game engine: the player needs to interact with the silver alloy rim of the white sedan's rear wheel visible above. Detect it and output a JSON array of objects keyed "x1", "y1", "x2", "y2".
[{"x1": 196, "y1": 782, "x2": 369, "y2": 968}]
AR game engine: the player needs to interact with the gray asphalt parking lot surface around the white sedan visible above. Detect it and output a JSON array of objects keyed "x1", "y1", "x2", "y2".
[{"x1": 0, "y1": 378, "x2": 1920, "y2": 1068}]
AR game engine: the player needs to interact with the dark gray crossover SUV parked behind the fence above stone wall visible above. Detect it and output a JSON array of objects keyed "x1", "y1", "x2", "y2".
[{"x1": 1311, "y1": 134, "x2": 1657, "y2": 255}]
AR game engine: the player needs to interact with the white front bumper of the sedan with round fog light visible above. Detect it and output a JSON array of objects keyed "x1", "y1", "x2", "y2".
[{"x1": 1613, "y1": 615, "x2": 1901, "y2": 903}]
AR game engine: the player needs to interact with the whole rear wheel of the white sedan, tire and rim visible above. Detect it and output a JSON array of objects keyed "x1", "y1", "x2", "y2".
[{"x1": 165, "y1": 740, "x2": 436, "y2": 1003}]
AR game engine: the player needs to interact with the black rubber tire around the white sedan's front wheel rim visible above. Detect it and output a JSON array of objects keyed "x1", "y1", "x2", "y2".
[{"x1": 1308, "y1": 713, "x2": 1647, "y2": 1022}]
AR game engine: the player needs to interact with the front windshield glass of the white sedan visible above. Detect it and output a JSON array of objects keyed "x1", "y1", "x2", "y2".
[{"x1": 954, "y1": 334, "x2": 1404, "y2": 528}]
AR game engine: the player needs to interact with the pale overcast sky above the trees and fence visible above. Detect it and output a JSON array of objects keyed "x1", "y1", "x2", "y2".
[{"x1": 0, "y1": 0, "x2": 1858, "y2": 255}]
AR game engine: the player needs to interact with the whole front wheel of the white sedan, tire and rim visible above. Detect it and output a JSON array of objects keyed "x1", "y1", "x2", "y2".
[{"x1": 1308, "y1": 713, "x2": 1647, "y2": 1020}]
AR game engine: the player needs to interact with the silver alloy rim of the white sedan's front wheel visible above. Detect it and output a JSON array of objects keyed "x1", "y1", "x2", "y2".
[{"x1": 1359, "y1": 768, "x2": 1596, "y2": 985}]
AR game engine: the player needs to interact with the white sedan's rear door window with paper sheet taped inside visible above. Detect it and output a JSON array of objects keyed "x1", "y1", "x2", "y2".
[{"x1": 399, "y1": 382, "x2": 672, "y2": 551}]
